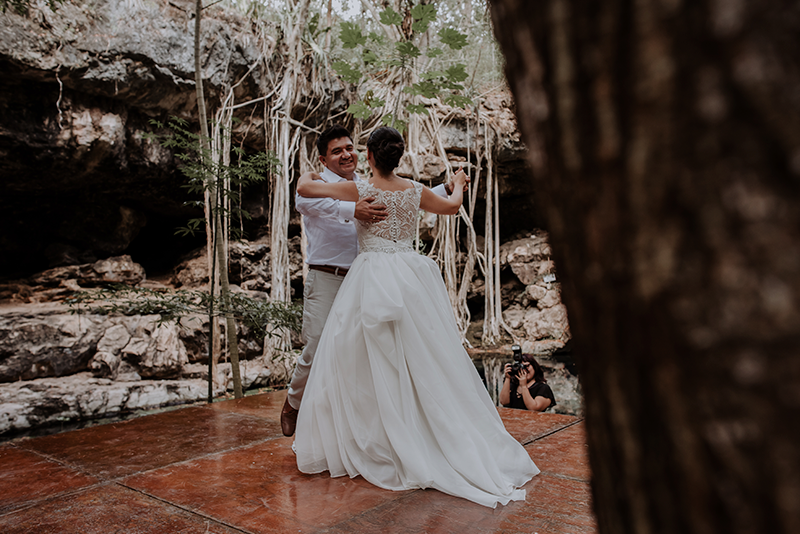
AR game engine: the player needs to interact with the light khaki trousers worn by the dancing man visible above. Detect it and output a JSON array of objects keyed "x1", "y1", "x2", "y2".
[{"x1": 289, "y1": 269, "x2": 344, "y2": 410}]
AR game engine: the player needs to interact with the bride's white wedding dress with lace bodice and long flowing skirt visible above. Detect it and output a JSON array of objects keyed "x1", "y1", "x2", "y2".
[{"x1": 295, "y1": 181, "x2": 539, "y2": 507}]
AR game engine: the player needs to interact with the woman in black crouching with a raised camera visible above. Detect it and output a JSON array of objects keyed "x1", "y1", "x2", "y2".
[{"x1": 500, "y1": 345, "x2": 556, "y2": 412}]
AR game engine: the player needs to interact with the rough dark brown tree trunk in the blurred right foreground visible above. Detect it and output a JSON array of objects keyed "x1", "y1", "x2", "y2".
[{"x1": 491, "y1": 0, "x2": 800, "y2": 534}]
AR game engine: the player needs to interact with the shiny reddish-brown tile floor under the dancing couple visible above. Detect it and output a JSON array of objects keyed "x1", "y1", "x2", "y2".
[{"x1": 0, "y1": 391, "x2": 596, "y2": 534}]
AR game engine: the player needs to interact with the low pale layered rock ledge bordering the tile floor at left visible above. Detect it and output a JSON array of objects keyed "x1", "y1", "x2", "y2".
[{"x1": 0, "y1": 303, "x2": 283, "y2": 435}]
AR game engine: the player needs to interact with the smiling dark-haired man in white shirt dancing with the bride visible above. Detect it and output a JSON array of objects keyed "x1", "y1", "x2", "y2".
[{"x1": 281, "y1": 124, "x2": 466, "y2": 436}]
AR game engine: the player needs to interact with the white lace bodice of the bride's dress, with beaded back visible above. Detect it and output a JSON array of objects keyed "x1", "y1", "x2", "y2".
[{"x1": 356, "y1": 181, "x2": 422, "y2": 253}]
